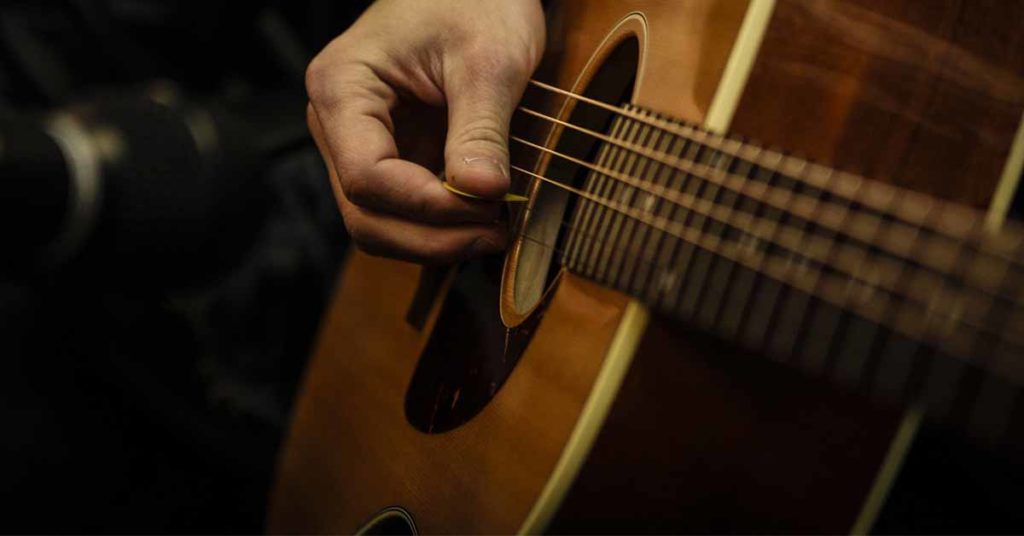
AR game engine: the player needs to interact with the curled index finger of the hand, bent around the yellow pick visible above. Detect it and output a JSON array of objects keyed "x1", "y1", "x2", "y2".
[{"x1": 309, "y1": 62, "x2": 500, "y2": 223}]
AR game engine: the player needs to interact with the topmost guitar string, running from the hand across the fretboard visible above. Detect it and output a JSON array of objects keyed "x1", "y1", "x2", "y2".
[{"x1": 517, "y1": 79, "x2": 1020, "y2": 262}]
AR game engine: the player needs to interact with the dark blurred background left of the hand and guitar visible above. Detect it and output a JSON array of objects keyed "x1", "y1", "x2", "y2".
[{"x1": 0, "y1": 0, "x2": 369, "y2": 533}]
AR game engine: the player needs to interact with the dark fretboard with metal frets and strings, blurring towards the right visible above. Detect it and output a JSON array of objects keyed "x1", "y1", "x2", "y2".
[{"x1": 563, "y1": 108, "x2": 1024, "y2": 448}]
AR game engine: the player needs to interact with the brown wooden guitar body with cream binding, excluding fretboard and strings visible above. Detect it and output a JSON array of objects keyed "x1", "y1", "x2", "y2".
[{"x1": 268, "y1": 0, "x2": 1024, "y2": 533}]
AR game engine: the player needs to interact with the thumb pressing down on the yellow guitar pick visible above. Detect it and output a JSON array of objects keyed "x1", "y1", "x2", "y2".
[{"x1": 444, "y1": 70, "x2": 522, "y2": 199}]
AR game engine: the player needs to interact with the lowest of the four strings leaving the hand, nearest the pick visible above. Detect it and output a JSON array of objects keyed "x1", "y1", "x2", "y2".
[{"x1": 511, "y1": 159, "x2": 1021, "y2": 358}]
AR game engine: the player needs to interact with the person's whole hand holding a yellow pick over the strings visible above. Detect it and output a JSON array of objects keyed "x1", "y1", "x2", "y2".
[{"x1": 306, "y1": 0, "x2": 545, "y2": 262}]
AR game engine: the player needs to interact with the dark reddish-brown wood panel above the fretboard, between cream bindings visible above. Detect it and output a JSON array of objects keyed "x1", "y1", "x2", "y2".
[{"x1": 732, "y1": 0, "x2": 1024, "y2": 209}]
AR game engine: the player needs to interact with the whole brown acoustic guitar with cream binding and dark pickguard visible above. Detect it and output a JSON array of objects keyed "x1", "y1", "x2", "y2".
[{"x1": 268, "y1": 0, "x2": 1024, "y2": 533}]
